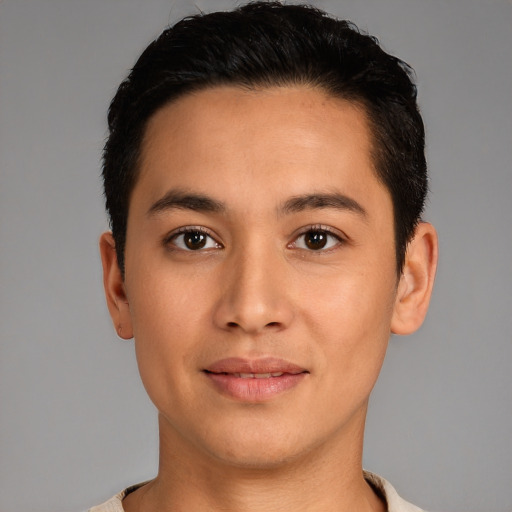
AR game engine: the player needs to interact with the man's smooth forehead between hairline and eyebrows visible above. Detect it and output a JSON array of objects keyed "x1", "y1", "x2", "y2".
[{"x1": 134, "y1": 87, "x2": 387, "y2": 218}]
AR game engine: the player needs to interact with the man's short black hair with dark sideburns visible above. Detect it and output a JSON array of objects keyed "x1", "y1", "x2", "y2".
[{"x1": 103, "y1": 1, "x2": 428, "y2": 276}]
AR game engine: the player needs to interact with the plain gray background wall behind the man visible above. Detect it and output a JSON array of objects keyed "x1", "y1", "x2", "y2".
[{"x1": 0, "y1": 0, "x2": 512, "y2": 512}]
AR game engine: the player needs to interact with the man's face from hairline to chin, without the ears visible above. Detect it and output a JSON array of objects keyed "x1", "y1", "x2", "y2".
[{"x1": 120, "y1": 87, "x2": 397, "y2": 467}]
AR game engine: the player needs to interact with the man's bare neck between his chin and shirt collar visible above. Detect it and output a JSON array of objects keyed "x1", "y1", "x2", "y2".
[{"x1": 123, "y1": 412, "x2": 385, "y2": 512}]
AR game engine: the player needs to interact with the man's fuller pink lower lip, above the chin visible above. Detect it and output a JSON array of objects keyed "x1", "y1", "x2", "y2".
[{"x1": 205, "y1": 372, "x2": 307, "y2": 402}]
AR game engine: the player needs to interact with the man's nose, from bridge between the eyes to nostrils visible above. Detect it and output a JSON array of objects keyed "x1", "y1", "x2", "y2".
[{"x1": 214, "y1": 247, "x2": 294, "y2": 335}]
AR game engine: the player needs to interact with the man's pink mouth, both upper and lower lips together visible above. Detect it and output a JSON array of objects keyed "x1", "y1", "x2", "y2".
[{"x1": 203, "y1": 357, "x2": 309, "y2": 403}]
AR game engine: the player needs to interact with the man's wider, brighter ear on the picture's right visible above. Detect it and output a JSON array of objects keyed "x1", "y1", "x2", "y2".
[{"x1": 391, "y1": 222, "x2": 438, "y2": 334}]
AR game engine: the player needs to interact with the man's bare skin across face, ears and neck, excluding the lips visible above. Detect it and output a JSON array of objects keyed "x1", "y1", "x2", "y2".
[{"x1": 100, "y1": 87, "x2": 437, "y2": 512}]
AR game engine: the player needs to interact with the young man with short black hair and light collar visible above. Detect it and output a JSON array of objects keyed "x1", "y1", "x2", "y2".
[{"x1": 92, "y1": 3, "x2": 437, "y2": 512}]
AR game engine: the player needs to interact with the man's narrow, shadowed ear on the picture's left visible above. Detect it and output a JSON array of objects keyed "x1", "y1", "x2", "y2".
[{"x1": 100, "y1": 232, "x2": 133, "y2": 340}]
